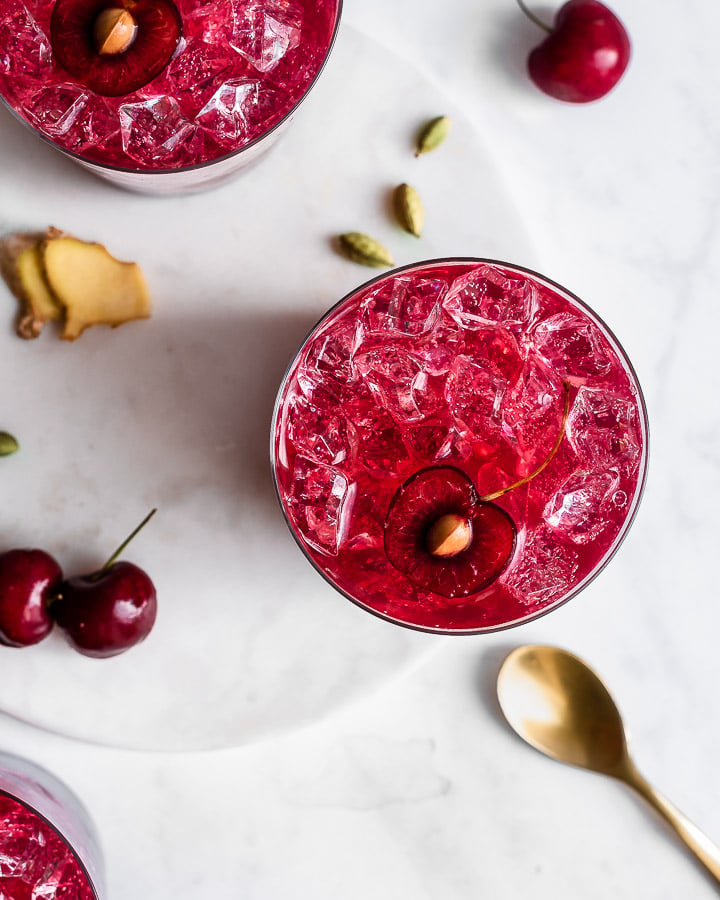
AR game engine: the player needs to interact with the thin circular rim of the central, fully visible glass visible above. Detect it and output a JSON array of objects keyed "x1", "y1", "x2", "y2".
[{"x1": 270, "y1": 256, "x2": 650, "y2": 636}]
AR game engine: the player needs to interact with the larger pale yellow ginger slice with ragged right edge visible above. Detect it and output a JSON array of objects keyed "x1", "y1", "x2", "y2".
[{"x1": 40, "y1": 236, "x2": 151, "y2": 341}]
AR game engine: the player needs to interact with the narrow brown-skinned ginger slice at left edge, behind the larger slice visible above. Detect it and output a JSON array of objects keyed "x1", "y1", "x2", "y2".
[{"x1": 0, "y1": 228, "x2": 62, "y2": 340}]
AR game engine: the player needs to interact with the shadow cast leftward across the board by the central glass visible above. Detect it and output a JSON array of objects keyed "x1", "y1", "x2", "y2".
[{"x1": 1, "y1": 298, "x2": 317, "y2": 567}]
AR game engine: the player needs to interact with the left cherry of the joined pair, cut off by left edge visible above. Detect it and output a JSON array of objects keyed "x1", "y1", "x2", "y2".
[{"x1": 0, "y1": 550, "x2": 62, "y2": 647}]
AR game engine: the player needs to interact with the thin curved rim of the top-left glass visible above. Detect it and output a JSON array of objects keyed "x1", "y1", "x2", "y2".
[{"x1": 0, "y1": 0, "x2": 344, "y2": 176}]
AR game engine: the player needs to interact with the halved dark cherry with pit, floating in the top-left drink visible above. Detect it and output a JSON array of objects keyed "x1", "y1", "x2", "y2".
[{"x1": 51, "y1": 0, "x2": 182, "y2": 97}]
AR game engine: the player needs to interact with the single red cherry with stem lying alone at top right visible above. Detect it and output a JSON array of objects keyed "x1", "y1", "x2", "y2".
[{"x1": 517, "y1": 0, "x2": 631, "y2": 103}]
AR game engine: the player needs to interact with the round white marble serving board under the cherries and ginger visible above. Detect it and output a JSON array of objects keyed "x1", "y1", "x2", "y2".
[{"x1": 0, "y1": 28, "x2": 533, "y2": 750}]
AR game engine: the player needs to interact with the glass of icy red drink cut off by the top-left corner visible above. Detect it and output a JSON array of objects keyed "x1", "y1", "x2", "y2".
[{"x1": 0, "y1": 0, "x2": 342, "y2": 194}]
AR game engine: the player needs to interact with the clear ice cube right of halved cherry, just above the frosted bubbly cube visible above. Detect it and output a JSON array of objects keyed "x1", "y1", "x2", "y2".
[{"x1": 543, "y1": 471, "x2": 620, "y2": 544}]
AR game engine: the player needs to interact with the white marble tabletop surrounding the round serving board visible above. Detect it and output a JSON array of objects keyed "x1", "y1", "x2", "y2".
[{"x1": 0, "y1": 0, "x2": 720, "y2": 900}]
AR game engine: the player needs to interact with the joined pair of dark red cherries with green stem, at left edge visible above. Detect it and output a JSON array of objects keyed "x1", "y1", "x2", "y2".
[{"x1": 0, "y1": 510, "x2": 157, "y2": 659}]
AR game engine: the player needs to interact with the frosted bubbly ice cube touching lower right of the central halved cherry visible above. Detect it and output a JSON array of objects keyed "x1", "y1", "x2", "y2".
[{"x1": 503, "y1": 528, "x2": 578, "y2": 606}]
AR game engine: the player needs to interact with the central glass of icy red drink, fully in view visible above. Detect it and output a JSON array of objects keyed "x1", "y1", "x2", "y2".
[{"x1": 271, "y1": 258, "x2": 648, "y2": 634}]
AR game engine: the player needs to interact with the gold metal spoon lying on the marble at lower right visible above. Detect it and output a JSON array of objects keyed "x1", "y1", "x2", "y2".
[{"x1": 497, "y1": 645, "x2": 720, "y2": 882}]
